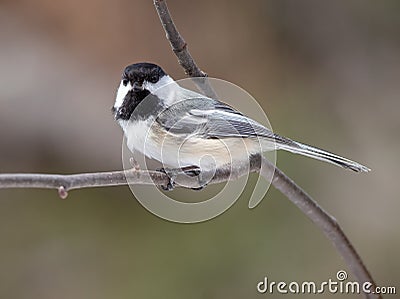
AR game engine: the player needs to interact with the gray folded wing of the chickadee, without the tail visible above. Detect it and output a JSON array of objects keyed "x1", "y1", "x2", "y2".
[{"x1": 157, "y1": 98, "x2": 280, "y2": 140}]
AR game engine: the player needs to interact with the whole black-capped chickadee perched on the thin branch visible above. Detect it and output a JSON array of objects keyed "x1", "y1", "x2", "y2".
[{"x1": 112, "y1": 63, "x2": 370, "y2": 190}]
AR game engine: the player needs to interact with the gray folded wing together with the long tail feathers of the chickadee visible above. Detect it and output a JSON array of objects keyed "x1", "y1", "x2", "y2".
[{"x1": 156, "y1": 97, "x2": 370, "y2": 172}]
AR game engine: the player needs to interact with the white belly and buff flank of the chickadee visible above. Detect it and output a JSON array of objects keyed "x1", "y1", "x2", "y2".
[{"x1": 121, "y1": 121, "x2": 268, "y2": 171}]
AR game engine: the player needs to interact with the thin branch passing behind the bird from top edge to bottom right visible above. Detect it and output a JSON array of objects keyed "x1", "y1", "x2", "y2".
[{"x1": 154, "y1": 0, "x2": 382, "y2": 298}]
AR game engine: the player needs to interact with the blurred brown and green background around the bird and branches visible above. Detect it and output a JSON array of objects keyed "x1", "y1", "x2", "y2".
[{"x1": 0, "y1": 0, "x2": 400, "y2": 299}]
